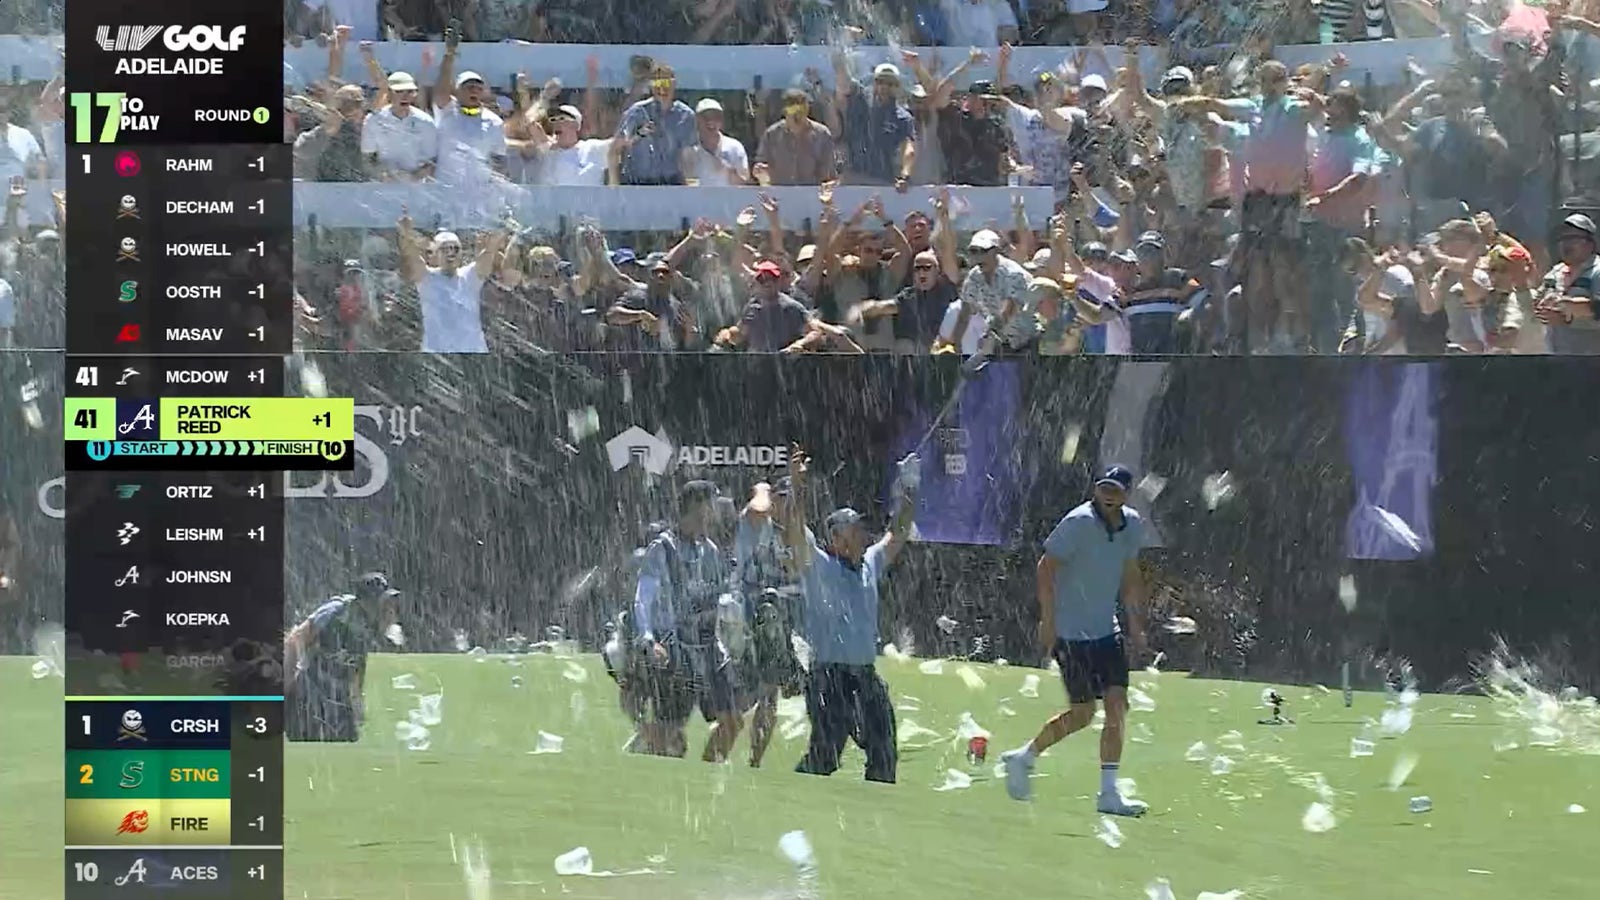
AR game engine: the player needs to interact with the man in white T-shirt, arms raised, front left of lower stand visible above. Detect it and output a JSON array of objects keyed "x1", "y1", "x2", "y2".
[{"x1": 397, "y1": 213, "x2": 507, "y2": 354}]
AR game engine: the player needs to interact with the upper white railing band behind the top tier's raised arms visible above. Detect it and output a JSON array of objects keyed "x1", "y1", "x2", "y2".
[{"x1": 0, "y1": 35, "x2": 1451, "y2": 91}]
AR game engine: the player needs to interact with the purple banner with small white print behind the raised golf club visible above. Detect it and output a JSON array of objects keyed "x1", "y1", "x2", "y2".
[{"x1": 886, "y1": 360, "x2": 1022, "y2": 544}]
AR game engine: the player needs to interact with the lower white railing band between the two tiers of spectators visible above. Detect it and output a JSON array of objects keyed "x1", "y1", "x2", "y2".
[{"x1": 26, "y1": 179, "x2": 1054, "y2": 231}]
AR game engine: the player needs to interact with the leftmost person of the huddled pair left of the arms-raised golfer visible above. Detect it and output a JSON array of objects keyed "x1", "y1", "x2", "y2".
[{"x1": 629, "y1": 480, "x2": 741, "y2": 762}]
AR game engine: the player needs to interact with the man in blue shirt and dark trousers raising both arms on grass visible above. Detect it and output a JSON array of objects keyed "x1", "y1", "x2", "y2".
[{"x1": 784, "y1": 447, "x2": 920, "y2": 785}]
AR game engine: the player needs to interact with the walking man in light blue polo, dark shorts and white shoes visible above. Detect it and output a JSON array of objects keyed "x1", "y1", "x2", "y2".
[{"x1": 1000, "y1": 466, "x2": 1149, "y2": 815}]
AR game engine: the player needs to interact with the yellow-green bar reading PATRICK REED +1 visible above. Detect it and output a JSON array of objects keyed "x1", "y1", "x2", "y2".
[{"x1": 158, "y1": 397, "x2": 355, "y2": 440}]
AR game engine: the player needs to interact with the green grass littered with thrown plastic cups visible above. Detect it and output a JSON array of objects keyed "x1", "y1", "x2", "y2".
[{"x1": 0, "y1": 655, "x2": 1600, "y2": 900}]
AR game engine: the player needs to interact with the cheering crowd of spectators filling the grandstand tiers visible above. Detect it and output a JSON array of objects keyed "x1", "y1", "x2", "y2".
[{"x1": 0, "y1": 0, "x2": 1600, "y2": 356}]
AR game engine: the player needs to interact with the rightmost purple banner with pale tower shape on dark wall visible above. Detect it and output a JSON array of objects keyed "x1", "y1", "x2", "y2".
[{"x1": 1344, "y1": 362, "x2": 1438, "y2": 560}]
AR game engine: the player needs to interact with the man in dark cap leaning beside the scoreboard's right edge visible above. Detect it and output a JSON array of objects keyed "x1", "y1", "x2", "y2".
[{"x1": 283, "y1": 572, "x2": 400, "y2": 743}]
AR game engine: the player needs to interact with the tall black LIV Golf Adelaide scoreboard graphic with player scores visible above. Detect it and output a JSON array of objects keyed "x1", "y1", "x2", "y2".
[{"x1": 56, "y1": 0, "x2": 339, "y2": 900}]
